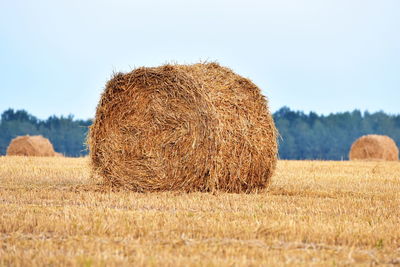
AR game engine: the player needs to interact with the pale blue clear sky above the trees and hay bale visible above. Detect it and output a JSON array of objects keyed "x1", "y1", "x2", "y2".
[{"x1": 0, "y1": 0, "x2": 400, "y2": 119}]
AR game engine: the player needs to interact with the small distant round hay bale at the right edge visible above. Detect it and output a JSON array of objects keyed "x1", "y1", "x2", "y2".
[{"x1": 349, "y1": 134, "x2": 399, "y2": 161}]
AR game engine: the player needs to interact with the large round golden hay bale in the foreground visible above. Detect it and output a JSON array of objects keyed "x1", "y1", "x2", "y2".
[{"x1": 88, "y1": 63, "x2": 277, "y2": 192}]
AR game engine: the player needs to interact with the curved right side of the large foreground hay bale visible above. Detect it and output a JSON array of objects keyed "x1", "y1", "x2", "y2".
[{"x1": 183, "y1": 63, "x2": 278, "y2": 192}]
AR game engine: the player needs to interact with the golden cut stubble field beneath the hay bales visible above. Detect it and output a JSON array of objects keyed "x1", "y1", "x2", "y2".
[{"x1": 0, "y1": 157, "x2": 400, "y2": 266}]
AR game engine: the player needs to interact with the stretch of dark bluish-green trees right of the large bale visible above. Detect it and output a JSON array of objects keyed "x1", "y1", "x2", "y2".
[{"x1": 274, "y1": 107, "x2": 400, "y2": 160}]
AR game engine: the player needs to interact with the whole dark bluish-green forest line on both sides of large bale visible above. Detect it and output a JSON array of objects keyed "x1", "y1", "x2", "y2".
[{"x1": 0, "y1": 107, "x2": 400, "y2": 160}]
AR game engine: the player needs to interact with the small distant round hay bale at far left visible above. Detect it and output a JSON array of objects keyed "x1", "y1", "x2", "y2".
[{"x1": 7, "y1": 135, "x2": 55, "y2": 157}]
